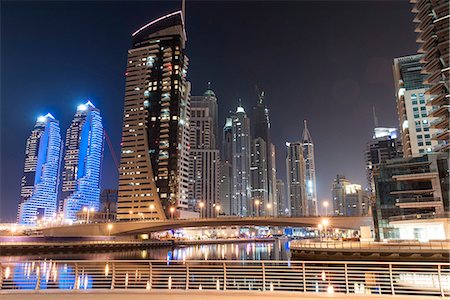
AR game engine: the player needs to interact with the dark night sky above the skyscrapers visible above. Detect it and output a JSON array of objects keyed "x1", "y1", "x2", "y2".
[{"x1": 0, "y1": 1, "x2": 417, "y2": 222}]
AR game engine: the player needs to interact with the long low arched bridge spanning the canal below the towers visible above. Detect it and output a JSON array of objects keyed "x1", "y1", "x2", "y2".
[{"x1": 42, "y1": 217, "x2": 373, "y2": 237}]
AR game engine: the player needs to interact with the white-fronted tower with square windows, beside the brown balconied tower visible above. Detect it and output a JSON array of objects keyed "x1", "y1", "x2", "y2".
[{"x1": 393, "y1": 55, "x2": 437, "y2": 156}]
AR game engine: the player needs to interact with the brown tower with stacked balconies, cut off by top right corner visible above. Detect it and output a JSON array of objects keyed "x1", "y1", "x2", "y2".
[{"x1": 410, "y1": 0, "x2": 450, "y2": 152}]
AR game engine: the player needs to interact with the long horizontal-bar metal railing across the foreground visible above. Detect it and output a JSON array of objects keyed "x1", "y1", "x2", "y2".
[{"x1": 0, "y1": 260, "x2": 450, "y2": 297}]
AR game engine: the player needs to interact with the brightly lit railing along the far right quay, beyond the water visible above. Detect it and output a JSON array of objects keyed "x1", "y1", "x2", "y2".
[{"x1": 290, "y1": 240, "x2": 450, "y2": 252}]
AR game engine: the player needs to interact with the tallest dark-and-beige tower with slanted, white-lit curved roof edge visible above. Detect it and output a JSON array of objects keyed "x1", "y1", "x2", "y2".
[{"x1": 117, "y1": 11, "x2": 190, "y2": 220}]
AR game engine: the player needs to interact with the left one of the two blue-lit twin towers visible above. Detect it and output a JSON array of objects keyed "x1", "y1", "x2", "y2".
[{"x1": 17, "y1": 114, "x2": 62, "y2": 225}]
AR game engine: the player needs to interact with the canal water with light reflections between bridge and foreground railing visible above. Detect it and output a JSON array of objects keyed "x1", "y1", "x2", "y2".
[{"x1": 0, "y1": 239, "x2": 291, "y2": 262}]
